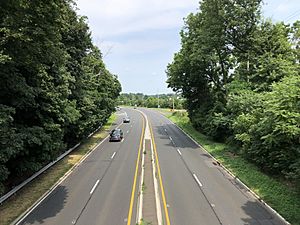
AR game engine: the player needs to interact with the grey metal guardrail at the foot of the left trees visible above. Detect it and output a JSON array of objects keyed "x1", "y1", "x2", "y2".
[{"x1": 0, "y1": 124, "x2": 102, "y2": 205}]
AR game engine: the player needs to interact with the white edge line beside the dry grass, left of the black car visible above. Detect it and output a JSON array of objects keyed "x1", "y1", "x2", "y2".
[{"x1": 11, "y1": 123, "x2": 122, "y2": 225}]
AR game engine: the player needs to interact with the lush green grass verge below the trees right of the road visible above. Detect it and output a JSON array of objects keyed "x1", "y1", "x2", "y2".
[{"x1": 159, "y1": 110, "x2": 300, "y2": 225}]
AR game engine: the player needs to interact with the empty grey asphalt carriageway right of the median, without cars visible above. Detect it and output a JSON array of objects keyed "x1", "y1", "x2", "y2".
[{"x1": 143, "y1": 109, "x2": 284, "y2": 225}]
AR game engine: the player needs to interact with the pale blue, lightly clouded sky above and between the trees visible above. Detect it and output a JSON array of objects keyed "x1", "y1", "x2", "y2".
[{"x1": 76, "y1": 0, "x2": 300, "y2": 94}]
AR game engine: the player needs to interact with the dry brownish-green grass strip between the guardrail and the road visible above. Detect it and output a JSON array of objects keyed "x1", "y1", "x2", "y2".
[{"x1": 0, "y1": 114, "x2": 117, "y2": 225}]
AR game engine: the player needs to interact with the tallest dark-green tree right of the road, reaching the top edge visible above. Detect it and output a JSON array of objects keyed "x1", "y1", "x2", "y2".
[{"x1": 167, "y1": 0, "x2": 261, "y2": 138}]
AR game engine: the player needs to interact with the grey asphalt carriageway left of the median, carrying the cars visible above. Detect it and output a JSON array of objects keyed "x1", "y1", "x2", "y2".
[{"x1": 18, "y1": 109, "x2": 143, "y2": 225}]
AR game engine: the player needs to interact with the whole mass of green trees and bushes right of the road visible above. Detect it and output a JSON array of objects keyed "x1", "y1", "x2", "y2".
[{"x1": 167, "y1": 0, "x2": 300, "y2": 184}]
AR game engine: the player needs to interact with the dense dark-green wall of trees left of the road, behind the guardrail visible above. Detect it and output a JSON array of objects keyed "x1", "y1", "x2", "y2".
[{"x1": 0, "y1": 0, "x2": 121, "y2": 194}]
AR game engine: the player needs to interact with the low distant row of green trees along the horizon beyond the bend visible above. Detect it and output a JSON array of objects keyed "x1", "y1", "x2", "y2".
[{"x1": 117, "y1": 93, "x2": 184, "y2": 109}]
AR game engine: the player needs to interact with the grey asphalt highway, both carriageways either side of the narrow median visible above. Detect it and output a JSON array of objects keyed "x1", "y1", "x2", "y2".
[{"x1": 18, "y1": 108, "x2": 284, "y2": 225}]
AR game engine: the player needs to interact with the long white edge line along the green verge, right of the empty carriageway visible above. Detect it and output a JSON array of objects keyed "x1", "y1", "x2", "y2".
[{"x1": 157, "y1": 110, "x2": 291, "y2": 225}]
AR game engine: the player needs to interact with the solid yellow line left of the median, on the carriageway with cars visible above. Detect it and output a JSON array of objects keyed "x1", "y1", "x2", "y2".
[{"x1": 127, "y1": 115, "x2": 145, "y2": 225}]
